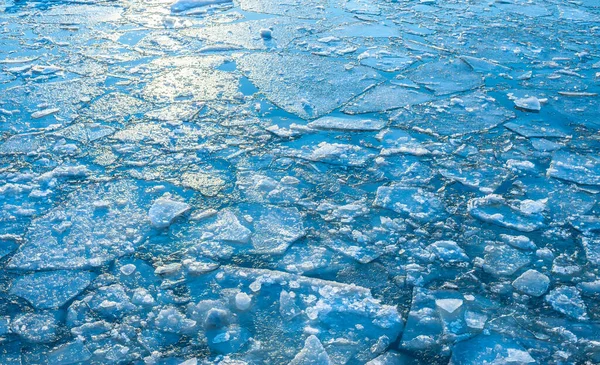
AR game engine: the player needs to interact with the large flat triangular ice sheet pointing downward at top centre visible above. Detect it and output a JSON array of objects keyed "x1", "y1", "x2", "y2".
[{"x1": 238, "y1": 53, "x2": 381, "y2": 119}]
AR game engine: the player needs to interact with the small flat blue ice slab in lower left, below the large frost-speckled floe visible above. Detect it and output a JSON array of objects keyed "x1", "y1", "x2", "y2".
[{"x1": 10, "y1": 270, "x2": 93, "y2": 309}]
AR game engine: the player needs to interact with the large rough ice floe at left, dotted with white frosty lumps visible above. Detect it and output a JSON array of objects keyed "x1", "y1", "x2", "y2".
[{"x1": 8, "y1": 181, "x2": 149, "y2": 270}]
